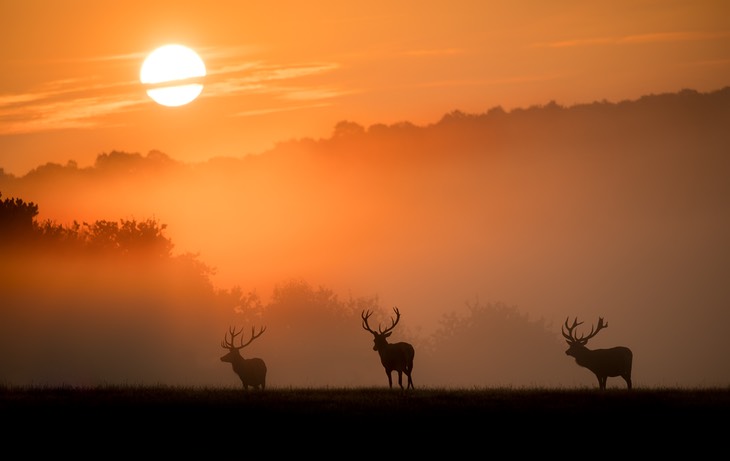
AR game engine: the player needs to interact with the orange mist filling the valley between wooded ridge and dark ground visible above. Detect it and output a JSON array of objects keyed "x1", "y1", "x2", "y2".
[{"x1": 0, "y1": 88, "x2": 730, "y2": 388}]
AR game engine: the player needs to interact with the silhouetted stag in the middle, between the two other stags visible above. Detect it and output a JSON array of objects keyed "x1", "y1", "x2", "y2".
[{"x1": 361, "y1": 307, "x2": 416, "y2": 389}]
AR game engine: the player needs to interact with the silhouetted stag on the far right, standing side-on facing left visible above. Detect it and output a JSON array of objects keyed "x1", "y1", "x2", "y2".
[{"x1": 562, "y1": 317, "x2": 634, "y2": 390}]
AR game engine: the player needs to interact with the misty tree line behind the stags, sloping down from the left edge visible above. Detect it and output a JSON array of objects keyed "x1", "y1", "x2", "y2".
[{"x1": 0, "y1": 190, "x2": 580, "y2": 387}]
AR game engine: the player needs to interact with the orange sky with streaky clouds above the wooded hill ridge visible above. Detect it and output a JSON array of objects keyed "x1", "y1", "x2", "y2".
[{"x1": 0, "y1": 0, "x2": 730, "y2": 175}]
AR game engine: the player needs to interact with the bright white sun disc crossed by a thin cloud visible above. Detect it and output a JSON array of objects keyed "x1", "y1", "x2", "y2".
[{"x1": 139, "y1": 44, "x2": 205, "y2": 107}]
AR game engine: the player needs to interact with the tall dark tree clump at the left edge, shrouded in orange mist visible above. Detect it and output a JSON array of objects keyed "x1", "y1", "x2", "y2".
[{"x1": 0, "y1": 190, "x2": 230, "y2": 385}]
